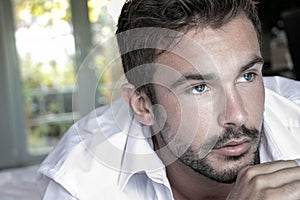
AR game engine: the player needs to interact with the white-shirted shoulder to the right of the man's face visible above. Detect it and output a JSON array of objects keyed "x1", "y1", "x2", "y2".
[{"x1": 262, "y1": 77, "x2": 300, "y2": 160}]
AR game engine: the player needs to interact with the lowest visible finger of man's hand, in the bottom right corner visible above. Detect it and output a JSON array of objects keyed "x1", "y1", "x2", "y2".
[{"x1": 264, "y1": 181, "x2": 300, "y2": 200}]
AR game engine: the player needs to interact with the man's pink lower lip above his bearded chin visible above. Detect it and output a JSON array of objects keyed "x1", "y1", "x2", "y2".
[{"x1": 213, "y1": 142, "x2": 250, "y2": 156}]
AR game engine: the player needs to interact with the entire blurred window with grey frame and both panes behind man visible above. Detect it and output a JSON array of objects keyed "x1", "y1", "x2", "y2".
[{"x1": 0, "y1": 0, "x2": 124, "y2": 166}]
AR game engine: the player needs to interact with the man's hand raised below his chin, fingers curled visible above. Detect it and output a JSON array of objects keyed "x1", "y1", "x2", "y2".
[{"x1": 227, "y1": 160, "x2": 300, "y2": 200}]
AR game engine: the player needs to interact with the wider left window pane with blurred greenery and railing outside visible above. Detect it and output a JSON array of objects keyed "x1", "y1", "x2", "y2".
[{"x1": 13, "y1": 0, "x2": 76, "y2": 155}]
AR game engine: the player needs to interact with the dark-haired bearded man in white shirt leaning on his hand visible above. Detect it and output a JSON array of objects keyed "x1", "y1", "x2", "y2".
[{"x1": 39, "y1": 0, "x2": 300, "y2": 200}]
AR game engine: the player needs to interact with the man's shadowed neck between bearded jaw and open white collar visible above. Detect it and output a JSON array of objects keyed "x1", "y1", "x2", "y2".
[{"x1": 153, "y1": 136, "x2": 232, "y2": 200}]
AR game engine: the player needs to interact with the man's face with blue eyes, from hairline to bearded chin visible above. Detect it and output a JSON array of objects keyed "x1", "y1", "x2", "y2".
[{"x1": 153, "y1": 16, "x2": 264, "y2": 183}]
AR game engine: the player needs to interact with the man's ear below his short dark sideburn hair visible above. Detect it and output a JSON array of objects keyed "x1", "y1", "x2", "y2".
[{"x1": 121, "y1": 83, "x2": 154, "y2": 126}]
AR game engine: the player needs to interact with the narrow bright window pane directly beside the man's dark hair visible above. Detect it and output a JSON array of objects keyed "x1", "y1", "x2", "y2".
[{"x1": 84, "y1": 0, "x2": 125, "y2": 106}]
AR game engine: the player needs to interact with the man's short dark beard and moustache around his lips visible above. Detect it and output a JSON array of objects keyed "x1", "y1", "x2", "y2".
[{"x1": 161, "y1": 125, "x2": 262, "y2": 184}]
